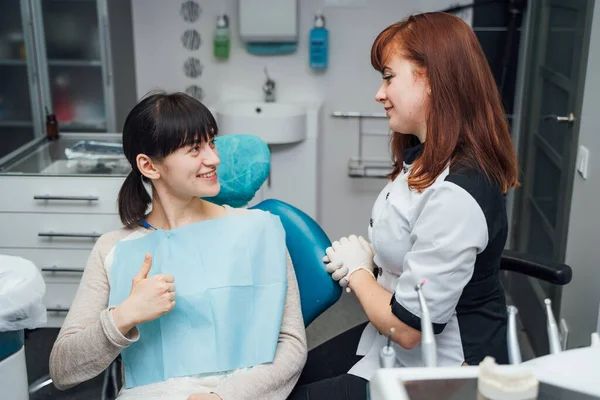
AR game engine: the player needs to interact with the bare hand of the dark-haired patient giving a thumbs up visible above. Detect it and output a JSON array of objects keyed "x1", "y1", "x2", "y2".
[{"x1": 112, "y1": 254, "x2": 175, "y2": 335}]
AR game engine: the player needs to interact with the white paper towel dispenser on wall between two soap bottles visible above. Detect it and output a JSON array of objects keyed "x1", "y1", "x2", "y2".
[{"x1": 239, "y1": 0, "x2": 298, "y2": 43}]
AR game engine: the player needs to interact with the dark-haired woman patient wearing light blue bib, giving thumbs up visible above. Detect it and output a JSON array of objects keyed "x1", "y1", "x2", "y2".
[{"x1": 50, "y1": 93, "x2": 307, "y2": 400}]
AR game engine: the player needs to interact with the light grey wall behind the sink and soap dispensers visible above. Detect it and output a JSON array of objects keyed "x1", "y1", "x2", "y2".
[{"x1": 132, "y1": 0, "x2": 470, "y2": 240}]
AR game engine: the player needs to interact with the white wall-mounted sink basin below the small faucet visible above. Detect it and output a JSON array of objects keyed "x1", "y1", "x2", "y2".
[{"x1": 215, "y1": 101, "x2": 306, "y2": 144}]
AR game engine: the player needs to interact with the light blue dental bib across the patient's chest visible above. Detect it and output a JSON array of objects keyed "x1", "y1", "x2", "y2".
[{"x1": 109, "y1": 211, "x2": 287, "y2": 388}]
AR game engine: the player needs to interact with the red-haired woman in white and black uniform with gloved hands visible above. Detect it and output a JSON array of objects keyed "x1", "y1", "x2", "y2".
[{"x1": 291, "y1": 13, "x2": 518, "y2": 400}]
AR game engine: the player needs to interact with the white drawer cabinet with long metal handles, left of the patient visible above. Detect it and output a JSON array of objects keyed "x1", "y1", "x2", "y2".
[{"x1": 0, "y1": 134, "x2": 125, "y2": 327}]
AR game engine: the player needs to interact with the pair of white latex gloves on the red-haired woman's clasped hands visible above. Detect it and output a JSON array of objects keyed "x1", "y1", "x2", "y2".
[{"x1": 323, "y1": 235, "x2": 375, "y2": 292}]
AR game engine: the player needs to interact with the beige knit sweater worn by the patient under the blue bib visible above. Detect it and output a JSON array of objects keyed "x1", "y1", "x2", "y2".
[{"x1": 50, "y1": 207, "x2": 307, "y2": 400}]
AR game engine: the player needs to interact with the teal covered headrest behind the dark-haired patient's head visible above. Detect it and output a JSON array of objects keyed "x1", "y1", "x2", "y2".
[{"x1": 205, "y1": 135, "x2": 271, "y2": 207}]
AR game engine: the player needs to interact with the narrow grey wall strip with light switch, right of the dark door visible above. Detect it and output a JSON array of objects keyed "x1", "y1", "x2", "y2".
[{"x1": 561, "y1": 2, "x2": 600, "y2": 347}]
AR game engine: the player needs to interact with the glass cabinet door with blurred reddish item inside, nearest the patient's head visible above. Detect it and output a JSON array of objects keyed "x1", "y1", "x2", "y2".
[{"x1": 34, "y1": 0, "x2": 114, "y2": 132}]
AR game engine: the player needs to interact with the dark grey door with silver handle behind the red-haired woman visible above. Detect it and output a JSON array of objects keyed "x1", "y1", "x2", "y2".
[{"x1": 509, "y1": 0, "x2": 594, "y2": 356}]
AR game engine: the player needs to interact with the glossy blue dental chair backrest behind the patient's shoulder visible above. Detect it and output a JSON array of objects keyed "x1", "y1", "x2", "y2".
[{"x1": 251, "y1": 199, "x2": 342, "y2": 326}]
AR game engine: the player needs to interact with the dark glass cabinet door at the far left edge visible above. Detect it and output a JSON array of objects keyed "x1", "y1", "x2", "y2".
[{"x1": 0, "y1": 0, "x2": 41, "y2": 158}]
